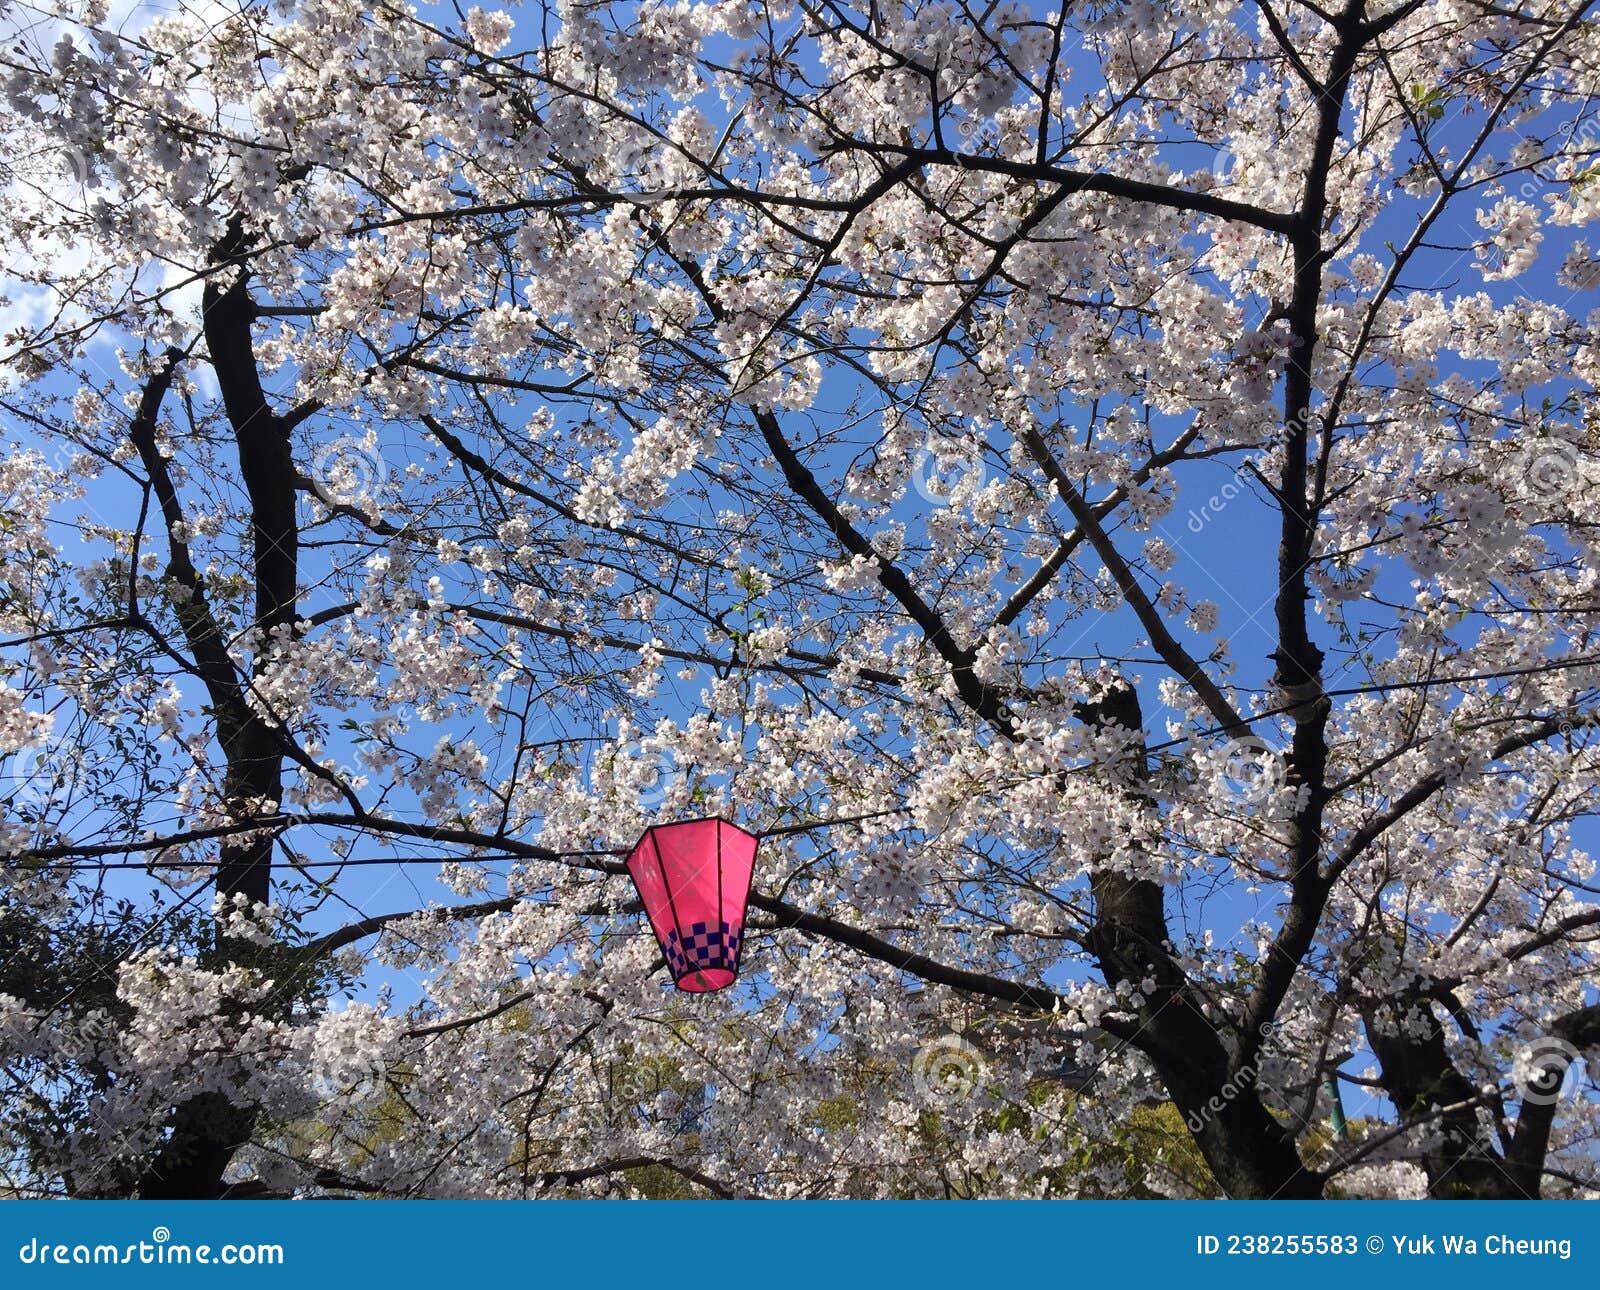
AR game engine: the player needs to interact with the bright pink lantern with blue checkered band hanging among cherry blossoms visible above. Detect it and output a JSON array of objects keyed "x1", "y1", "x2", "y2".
[{"x1": 627, "y1": 819, "x2": 758, "y2": 994}]
